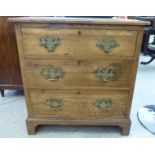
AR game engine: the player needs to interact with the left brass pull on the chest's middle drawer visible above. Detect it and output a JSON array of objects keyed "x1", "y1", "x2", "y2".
[{"x1": 41, "y1": 67, "x2": 63, "y2": 81}]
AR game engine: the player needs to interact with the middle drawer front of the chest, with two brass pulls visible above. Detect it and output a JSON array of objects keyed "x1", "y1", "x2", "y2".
[{"x1": 25, "y1": 60, "x2": 132, "y2": 89}]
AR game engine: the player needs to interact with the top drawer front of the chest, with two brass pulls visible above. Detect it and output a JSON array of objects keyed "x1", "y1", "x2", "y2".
[{"x1": 21, "y1": 28, "x2": 137, "y2": 59}]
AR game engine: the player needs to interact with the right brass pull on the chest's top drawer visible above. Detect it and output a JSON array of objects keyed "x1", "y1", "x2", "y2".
[{"x1": 96, "y1": 39, "x2": 119, "y2": 53}]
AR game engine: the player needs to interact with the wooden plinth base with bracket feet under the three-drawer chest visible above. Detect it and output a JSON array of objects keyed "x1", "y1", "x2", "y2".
[{"x1": 26, "y1": 118, "x2": 131, "y2": 136}]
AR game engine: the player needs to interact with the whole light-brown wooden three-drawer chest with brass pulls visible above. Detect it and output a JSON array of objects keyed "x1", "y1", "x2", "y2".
[{"x1": 10, "y1": 17, "x2": 149, "y2": 135}]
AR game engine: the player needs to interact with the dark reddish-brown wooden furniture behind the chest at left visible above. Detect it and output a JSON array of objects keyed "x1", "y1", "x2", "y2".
[{"x1": 0, "y1": 16, "x2": 22, "y2": 95}]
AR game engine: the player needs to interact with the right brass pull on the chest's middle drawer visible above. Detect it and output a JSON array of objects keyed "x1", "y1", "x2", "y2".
[{"x1": 96, "y1": 68, "x2": 118, "y2": 82}]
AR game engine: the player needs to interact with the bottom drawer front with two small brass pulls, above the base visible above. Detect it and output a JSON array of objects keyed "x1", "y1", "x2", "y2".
[{"x1": 30, "y1": 90, "x2": 128, "y2": 119}]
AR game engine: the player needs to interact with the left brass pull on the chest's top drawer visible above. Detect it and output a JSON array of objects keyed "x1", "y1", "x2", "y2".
[{"x1": 39, "y1": 37, "x2": 61, "y2": 53}]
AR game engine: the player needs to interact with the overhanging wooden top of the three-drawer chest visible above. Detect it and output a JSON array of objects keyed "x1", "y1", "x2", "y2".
[{"x1": 8, "y1": 17, "x2": 150, "y2": 26}]
